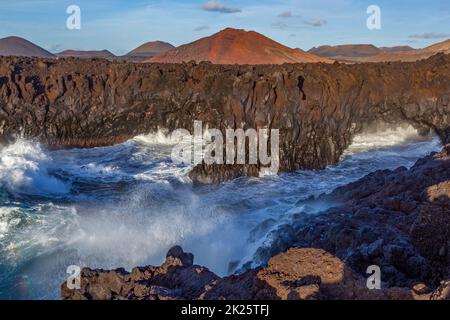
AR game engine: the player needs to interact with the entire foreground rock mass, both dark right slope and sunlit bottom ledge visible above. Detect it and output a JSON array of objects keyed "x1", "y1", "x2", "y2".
[{"x1": 61, "y1": 145, "x2": 450, "y2": 300}]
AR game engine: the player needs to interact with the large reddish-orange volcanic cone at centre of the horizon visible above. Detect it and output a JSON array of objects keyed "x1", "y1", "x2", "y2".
[{"x1": 145, "y1": 28, "x2": 332, "y2": 64}]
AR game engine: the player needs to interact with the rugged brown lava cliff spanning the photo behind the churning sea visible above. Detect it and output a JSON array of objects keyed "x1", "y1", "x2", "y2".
[{"x1": 0, "y1": 55, "x2": 450, "y2": 182}]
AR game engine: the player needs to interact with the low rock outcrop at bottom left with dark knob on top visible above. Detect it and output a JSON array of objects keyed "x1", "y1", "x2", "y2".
[{"x1": 61, "y1": 247, "x2": 219, "y2": 300}]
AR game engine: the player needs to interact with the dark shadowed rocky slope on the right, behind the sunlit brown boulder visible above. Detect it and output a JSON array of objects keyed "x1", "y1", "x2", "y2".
[{"x1": 253, "y1": 145, "x2": 450, "y2": 287}]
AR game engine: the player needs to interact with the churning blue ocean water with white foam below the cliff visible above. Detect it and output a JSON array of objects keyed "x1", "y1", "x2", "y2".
[{"x1": 0, "y1": 127, "x2": 441, "y2": 299}]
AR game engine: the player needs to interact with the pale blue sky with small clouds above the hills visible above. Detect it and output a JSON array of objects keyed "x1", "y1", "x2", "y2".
[{"x1": 0, "y1": 0, "x2": 450, "y2": 54}]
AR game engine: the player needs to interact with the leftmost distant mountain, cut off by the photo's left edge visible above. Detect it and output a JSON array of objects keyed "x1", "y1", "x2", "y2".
[{"x1": 0, "y1": 37, "x2": 55, "y2": 58}]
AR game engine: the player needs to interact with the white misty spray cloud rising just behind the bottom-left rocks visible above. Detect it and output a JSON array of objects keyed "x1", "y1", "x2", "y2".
[{"x1": 68, "y1": 191, "x2": 237, "y2": 268}]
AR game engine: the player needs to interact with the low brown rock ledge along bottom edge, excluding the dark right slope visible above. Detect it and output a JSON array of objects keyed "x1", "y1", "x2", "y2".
[{"x1": 61, "y1": 247, "x2": 450, "y2": 300}]
